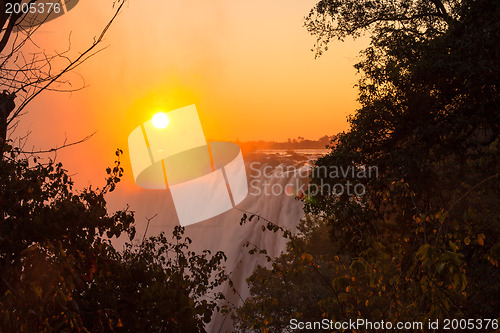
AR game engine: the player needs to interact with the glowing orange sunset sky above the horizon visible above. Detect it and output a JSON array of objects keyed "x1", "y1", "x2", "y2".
[{"x1": 13, "y1": 0, "x2": 366, "y2": 185}]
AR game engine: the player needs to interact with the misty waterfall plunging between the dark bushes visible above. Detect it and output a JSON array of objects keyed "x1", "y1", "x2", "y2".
[{"x1": 110, "y1": 150, "x2": 320, "y2": 332}]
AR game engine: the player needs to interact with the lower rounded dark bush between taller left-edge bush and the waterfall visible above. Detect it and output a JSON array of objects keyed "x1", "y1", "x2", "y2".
[{"x1": 81, "y1": 227, "x2": 227, "y2": 332}]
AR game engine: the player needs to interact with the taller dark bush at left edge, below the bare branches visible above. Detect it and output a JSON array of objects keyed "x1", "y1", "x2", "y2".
[{"x1": 0, "y1": 144, "x2": 135, "y2": 332}]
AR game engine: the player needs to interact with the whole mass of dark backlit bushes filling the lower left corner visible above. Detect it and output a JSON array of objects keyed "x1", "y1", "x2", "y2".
[{"x1": 0, "y1": 145, "x2": 227, "y2": 332}]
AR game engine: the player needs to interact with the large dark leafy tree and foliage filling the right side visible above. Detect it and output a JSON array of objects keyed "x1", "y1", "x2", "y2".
[{"x1": 239, "y1": 0, "x2": 500, "y2": 332}]
